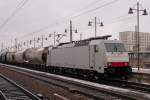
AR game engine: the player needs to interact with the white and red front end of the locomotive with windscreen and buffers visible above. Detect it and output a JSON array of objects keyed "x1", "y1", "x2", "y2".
[{"x1": 104, "y1": 41, "x2": 132, "y2": 75}]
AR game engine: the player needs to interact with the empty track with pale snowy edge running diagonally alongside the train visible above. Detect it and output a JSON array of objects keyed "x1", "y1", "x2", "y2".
[{"x1": 0, "y1": 65, "x2": 150, "y2": 100}]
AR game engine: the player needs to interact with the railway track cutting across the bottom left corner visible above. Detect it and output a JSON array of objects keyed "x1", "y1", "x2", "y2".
[{"x1": 0, "y1": 74, "x2": 41, "y2": 100}]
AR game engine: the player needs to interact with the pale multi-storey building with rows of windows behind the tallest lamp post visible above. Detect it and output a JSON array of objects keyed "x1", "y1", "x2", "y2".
[{"x1": 119, "y1": 31, "x2": 150, "y2": 52}]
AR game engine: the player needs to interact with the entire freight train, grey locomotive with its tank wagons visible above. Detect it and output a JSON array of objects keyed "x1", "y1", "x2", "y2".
[{"x1": 0, "y1": 35, "x2": 132, "y2": 76}]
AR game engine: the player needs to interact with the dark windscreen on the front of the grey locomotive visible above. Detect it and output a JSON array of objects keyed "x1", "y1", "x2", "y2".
[{"x1": 105, "y1": 43, "x2": 126, "y2": 52}]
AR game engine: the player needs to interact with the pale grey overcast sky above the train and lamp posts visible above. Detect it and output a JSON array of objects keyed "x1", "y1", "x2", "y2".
[{"x1": 0, "y1": 0, "x2": 150, "y2": 48}]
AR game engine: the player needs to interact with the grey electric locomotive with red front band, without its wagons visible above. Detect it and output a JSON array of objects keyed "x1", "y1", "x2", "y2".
[{"x1": 47, "y1": 35, "x2": 132, "y2": 76}]
